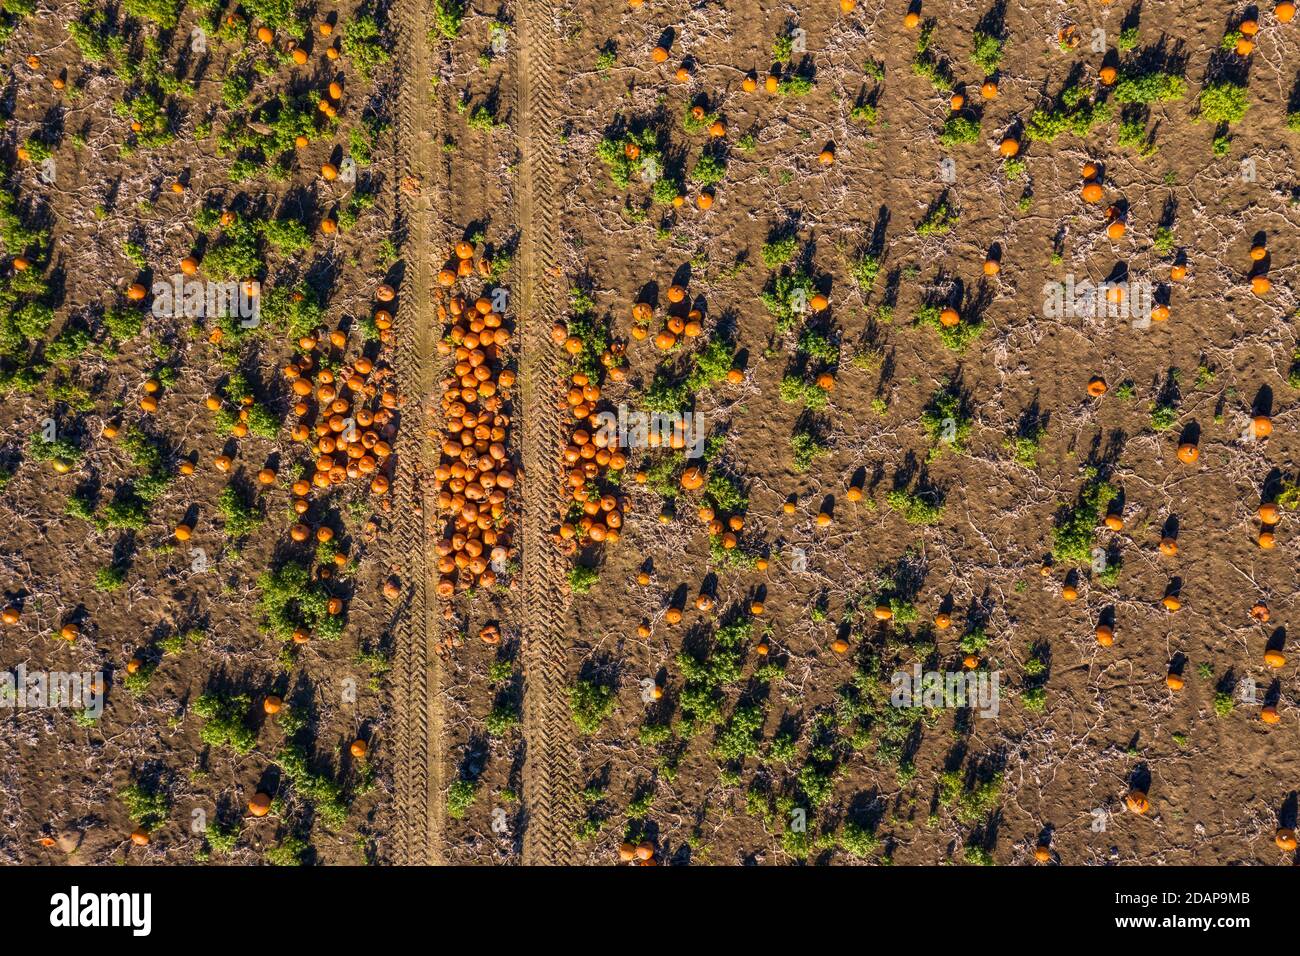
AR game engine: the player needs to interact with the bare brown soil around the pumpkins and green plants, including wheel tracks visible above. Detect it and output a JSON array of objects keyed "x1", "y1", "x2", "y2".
[{"x1": 0, "y1": 0, "x2": 1300, "y2": 865}]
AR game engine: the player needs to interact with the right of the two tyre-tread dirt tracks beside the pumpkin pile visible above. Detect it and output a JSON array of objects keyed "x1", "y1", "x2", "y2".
[{"x1": 515, "y1": 0, "x2": 577, "y2": 865}]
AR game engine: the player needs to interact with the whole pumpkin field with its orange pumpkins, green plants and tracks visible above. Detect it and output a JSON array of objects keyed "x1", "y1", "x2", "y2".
[{"x1": 0, "y1": 0, "x2": 1300, "y2": 865}]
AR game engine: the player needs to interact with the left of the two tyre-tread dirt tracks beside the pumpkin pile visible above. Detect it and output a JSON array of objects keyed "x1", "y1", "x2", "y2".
[{"x1": 389, "y1": 0, "x2": 443, "y2": 865}]
